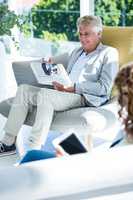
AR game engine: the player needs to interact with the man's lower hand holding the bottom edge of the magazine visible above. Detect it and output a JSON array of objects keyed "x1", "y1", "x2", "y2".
[{"x1": 53, "y1": 81, "x2": 75, "y2": 93}]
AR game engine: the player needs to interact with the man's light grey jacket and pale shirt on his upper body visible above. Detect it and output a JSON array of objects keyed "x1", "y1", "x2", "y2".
[{"x1": 67, "y1": 43, "x2": 119, "y2": 107}]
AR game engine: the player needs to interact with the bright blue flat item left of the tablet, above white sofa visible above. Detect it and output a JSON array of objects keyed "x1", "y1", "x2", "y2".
[{"x1": 20, "y1": 150, "x2": 56, "y2": 164}]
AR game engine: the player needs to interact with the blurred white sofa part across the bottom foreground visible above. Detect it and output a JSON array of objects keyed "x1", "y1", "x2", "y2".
[{"x1": 0, "y1": 145, "x2": 133, "y2": 200}]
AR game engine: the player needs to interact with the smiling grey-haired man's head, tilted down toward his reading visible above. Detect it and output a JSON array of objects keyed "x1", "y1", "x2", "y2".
[{"x1": 77, "y1": 15, "x2": 103, "y2": 53}]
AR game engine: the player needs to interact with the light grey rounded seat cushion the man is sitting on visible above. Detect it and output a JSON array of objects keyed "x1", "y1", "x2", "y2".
[{"x1": 0, "y1": 98, "x2": 117, "y2": 141}]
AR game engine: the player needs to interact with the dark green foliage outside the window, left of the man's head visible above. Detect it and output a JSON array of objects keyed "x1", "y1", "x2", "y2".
[{"x1": 31, "y1": 0, "x2": 80, "y2": 41}]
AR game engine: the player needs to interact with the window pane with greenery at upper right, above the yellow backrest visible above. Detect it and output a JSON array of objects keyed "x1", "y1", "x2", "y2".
[{"x1": 95, "y1": 0, "x2": 133, "y2": 26}]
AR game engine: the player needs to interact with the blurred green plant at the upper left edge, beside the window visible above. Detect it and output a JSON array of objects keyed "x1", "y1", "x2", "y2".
[{"x1": 0, "y1": 3, "x2": 17, "y2": 35}]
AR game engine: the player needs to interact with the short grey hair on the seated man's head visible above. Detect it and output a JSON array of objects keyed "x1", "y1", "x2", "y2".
[{"x1": 77, "y1": 15, "x2": 103, "y2": 32}]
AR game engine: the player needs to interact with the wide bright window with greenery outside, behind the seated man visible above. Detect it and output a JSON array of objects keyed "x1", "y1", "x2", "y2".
[{"x1": 0, "y1": 0, "x2": 133, "y2": 56}]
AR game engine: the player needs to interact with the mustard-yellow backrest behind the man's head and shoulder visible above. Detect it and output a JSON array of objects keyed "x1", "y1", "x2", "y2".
[{"x1": 102, "y1": 26, "x2": 133, "y2": 66}]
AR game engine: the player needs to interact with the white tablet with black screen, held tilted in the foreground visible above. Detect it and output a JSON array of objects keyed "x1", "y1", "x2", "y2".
[{"x1": 53, "y1": 133, "x2": 87, "y2": 154}]
